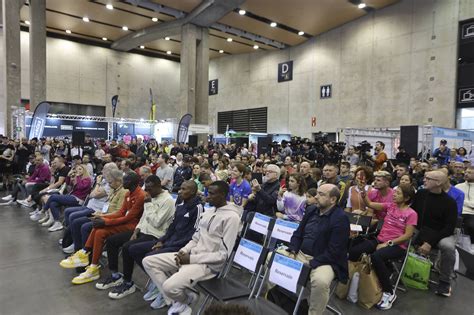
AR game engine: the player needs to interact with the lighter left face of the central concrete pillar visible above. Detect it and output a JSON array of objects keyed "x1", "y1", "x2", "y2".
[{"x1": 177, "y1": 24, "x2": 198, "y2": 119}]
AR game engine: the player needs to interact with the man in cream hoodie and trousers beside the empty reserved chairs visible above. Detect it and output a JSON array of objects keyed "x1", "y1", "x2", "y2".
[{"x1": 143, "y1": 181, "x2": 242, "y2": 314}]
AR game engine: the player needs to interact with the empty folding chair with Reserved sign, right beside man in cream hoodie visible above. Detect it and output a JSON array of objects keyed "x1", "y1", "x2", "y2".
[{"x1": 196, "y1": 238, "x2": 268, "y2": 314}]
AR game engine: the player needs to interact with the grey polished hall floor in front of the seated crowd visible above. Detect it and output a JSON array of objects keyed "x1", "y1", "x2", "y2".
[{"x1": 0, "y1": 200, "x2": 474, "y2": 315}]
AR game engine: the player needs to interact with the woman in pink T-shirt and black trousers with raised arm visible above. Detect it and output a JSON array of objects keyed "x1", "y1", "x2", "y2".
[{"x1": 349, "y1": 184, "x2": 418, "y2": 310}]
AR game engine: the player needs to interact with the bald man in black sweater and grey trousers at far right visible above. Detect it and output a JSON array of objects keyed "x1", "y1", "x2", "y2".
[{"x1": 412, "y1": 171, "x2": 458, "y2": 297}]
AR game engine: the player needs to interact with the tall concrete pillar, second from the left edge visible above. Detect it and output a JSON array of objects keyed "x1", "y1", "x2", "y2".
[{"x1": 30, "y1": 0, "x2": 46, "y2": 111}]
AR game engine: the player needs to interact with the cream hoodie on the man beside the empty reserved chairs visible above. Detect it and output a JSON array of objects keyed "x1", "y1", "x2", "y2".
[{"x1": 180, "y1": 203, "x2": 242, "y2": 273}]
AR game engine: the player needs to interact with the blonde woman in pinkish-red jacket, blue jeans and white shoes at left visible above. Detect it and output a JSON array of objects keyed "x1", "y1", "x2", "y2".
[{"x1": 41, "y1": 164, "x2": 92, "y2": 232}]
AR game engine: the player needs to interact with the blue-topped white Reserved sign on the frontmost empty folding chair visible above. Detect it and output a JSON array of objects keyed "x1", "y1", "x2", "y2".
[{"x1": 268, "y1": 253, "x2": 303, "y2": 293}]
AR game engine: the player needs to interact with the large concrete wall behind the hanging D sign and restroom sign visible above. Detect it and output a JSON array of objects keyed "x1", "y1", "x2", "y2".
[{"x1": 209, "y1": 0, "x2": 474, "y2": 136}]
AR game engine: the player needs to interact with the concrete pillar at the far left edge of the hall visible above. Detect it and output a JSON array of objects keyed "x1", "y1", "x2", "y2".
[{"x1": 0, "y1": 0, "x2": 23, "y2": 135}]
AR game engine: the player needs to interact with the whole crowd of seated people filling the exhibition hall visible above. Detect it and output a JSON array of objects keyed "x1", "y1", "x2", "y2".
[{"x1": 0, "y1": 136, "x2": 474, "y2": 314}]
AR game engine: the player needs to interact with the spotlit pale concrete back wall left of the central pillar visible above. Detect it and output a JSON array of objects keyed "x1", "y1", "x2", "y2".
[{"x1": 15, "y1": 32, "x2": 179, "y2": 119}]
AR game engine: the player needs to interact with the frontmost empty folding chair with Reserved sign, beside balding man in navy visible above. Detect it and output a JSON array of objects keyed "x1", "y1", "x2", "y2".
[{"x1": 235, "y1": 252, "x2": 311, "y2": 315}]
